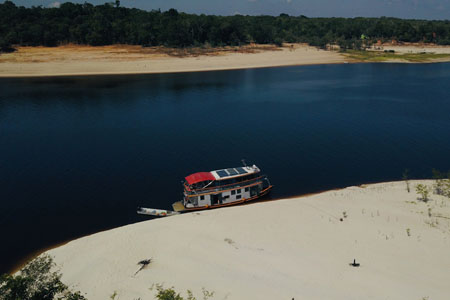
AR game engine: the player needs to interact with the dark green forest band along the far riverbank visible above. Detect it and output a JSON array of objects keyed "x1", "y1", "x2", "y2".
[{"x1": 0, "y1": 1, "x2": 450, "y2": 51}]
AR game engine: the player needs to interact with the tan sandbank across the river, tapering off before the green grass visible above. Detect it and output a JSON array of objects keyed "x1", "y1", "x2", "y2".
[{"x1": 0, "y1": 44, "x2": 346, "y2": 77}]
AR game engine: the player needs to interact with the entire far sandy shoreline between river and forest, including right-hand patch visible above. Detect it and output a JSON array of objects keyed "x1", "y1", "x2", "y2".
[{"x1": 0, "y1": 44, "x2": 450, "y2": 78}]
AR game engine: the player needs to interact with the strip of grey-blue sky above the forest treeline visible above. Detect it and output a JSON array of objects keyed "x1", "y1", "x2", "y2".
[{"x1": 6, "y1": 0, "x2": 450, "y2": 20}]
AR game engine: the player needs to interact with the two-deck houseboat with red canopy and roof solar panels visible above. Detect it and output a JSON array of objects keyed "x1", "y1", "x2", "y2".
[{"x1": 172, "y1": 165, "x2": 272, "y2": 211}]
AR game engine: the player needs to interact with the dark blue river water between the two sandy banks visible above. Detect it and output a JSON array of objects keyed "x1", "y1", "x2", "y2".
[{"x1": 0, "y1": 64, "x2": 450, "y2": 272}]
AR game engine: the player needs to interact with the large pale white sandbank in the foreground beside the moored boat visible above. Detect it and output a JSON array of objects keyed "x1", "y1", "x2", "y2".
[{"x1": 49, "y1": 181, "x2": 450, "y2": 300}]
